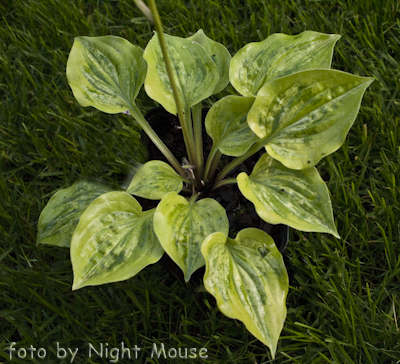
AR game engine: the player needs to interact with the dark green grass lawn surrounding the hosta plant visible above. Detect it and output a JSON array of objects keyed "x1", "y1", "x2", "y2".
[{"x1": 0, "y1": 0, "x2": 400, "y2": 364}]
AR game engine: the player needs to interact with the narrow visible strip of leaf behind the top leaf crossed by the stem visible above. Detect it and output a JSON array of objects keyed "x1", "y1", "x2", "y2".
[{"x1": 187, "y1": 29, "x2": 231, "y2": 94}]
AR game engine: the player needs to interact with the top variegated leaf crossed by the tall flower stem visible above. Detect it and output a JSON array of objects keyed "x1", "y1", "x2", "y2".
[{"x1": 143, "y1": 33, "x2": 219, "y2": 115}]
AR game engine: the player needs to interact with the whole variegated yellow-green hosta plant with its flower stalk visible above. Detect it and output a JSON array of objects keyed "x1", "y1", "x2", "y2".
[{"x1": 37, "y1": 1, "x2": 372, "y2": 357}]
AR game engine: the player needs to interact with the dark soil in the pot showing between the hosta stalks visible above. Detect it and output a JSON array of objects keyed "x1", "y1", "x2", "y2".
[{"x1": 141, "y1": 107, "x2": 289, "y2": 252}]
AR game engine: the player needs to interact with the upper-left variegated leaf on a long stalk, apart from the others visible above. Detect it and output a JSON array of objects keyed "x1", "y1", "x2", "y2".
[{"x1": 67, "y1": 36, "x2": 147, "y2": 114}]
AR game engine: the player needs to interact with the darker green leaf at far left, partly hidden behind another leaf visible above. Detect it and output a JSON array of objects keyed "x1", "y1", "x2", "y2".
[{"x1": 37, "y1": 180, "x2": 111, "y2": 247}]
